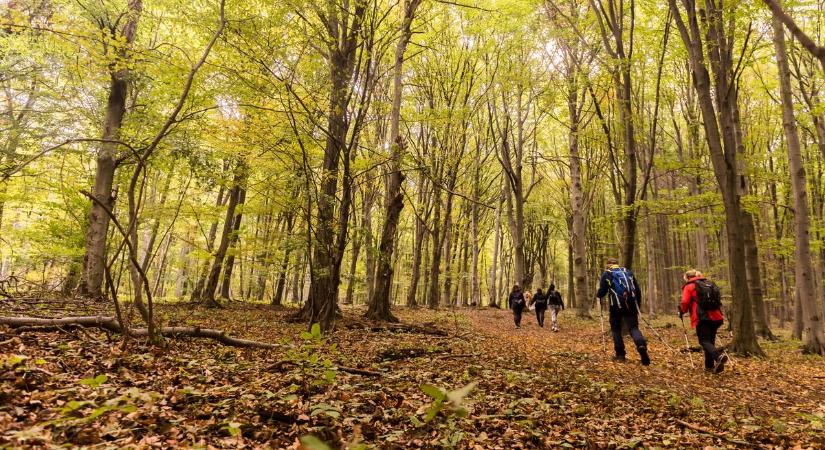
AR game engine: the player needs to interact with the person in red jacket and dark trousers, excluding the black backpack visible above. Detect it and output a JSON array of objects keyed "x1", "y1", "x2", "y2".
[{"x1": 679, "y1": 269, "x2": 728, "y2": 373}]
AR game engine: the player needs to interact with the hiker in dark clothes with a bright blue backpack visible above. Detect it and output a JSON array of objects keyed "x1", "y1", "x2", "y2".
[{"x1": 596, "y1": 258, "x2": 650, "y2": 366}]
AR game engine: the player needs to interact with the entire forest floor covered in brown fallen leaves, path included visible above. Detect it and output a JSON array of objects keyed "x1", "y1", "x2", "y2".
[{"x1": 0, "y1": 301, "x2": 825, "y2": 449}]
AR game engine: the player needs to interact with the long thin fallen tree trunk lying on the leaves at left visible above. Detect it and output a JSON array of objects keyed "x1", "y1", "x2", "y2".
[{"x1": 0, "y1": 316, "x2": 280, "y2": 350}]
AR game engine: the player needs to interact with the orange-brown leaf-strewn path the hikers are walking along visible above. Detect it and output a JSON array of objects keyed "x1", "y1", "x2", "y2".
[{"x1": 470, "y1": 310, "x2": 825, "y2": 446}]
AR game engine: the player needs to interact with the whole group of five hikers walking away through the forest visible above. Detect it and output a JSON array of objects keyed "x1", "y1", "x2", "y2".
[{"x1": 508, "y1": 258, "x2": 728, "y2": 373}]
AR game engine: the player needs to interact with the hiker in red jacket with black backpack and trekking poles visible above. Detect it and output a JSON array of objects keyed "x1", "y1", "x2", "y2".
[{"x1": 679, "y1": 269, "x2": 728, "y2": 373}]
